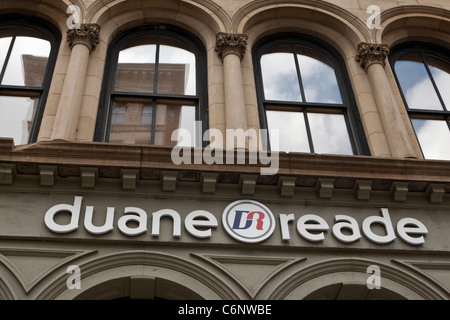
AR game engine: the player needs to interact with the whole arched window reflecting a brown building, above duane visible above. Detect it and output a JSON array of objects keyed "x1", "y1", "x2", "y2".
[{"x1": 95, "y1": 25, "x2": 208, "y2": 146}]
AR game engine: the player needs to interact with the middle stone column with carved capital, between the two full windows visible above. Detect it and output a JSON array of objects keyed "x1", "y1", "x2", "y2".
[{"x1": 216, "y1": 33, "x2": 248, "y2": 148}]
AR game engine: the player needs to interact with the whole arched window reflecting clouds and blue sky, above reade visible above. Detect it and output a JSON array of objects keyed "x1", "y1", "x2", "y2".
[{"x1": 253, "y1": 34, "x2": 368, "y2": 155}]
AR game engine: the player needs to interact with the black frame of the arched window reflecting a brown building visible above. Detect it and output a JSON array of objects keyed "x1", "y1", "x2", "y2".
[{"x1": 94, "y1": 23, "x2": 209, "y2": 146}]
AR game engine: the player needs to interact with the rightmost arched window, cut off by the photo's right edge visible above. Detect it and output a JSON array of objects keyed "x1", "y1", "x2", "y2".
[{"x1": 390, "y1": 43, "x2": 450, "y2": 160}]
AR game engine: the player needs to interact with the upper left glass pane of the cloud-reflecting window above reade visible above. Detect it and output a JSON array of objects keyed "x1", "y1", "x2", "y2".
[{"x1": 261, "y1": 45, "x2": 302, "y2": 102}]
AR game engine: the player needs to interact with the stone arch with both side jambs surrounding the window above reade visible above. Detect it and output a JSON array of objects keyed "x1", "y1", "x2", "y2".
[{"x1": 232, "y1": 0, "x2": 378, "y2": 155}]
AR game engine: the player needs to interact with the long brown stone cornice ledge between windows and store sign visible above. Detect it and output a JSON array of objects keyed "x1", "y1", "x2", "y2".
[{"x1": 0, "y1": 139, "x2": 450, "y2": 193}]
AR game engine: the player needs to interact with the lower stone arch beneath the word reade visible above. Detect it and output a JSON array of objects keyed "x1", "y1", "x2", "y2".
[{"x1": 269, "y1": 258, "x2": 448, "y2": 300}]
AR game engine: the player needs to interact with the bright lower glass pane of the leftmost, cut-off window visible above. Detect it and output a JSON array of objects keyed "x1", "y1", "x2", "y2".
[{"x1": 0, "y1": 96, "x2": 39, "y2": 145}]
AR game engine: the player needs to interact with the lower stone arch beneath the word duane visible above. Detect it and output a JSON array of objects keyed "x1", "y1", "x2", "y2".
[{"x1": 37, "y1": 251, "x2": 237, "y2": 300}]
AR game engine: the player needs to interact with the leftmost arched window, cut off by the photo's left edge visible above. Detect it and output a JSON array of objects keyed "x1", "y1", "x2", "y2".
[{"x1": 0, "y1": 16, "x2": 60, "y2": 145}]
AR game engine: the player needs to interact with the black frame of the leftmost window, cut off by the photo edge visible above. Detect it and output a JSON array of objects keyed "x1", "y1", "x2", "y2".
[{"x1": 0, "y1": 15, "x2": 62, "y2": 143}]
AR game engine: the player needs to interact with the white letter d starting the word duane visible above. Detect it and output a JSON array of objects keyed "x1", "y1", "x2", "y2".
[{"x1": 44, "y1": 197, "x2": 83, "y2": 233}]
